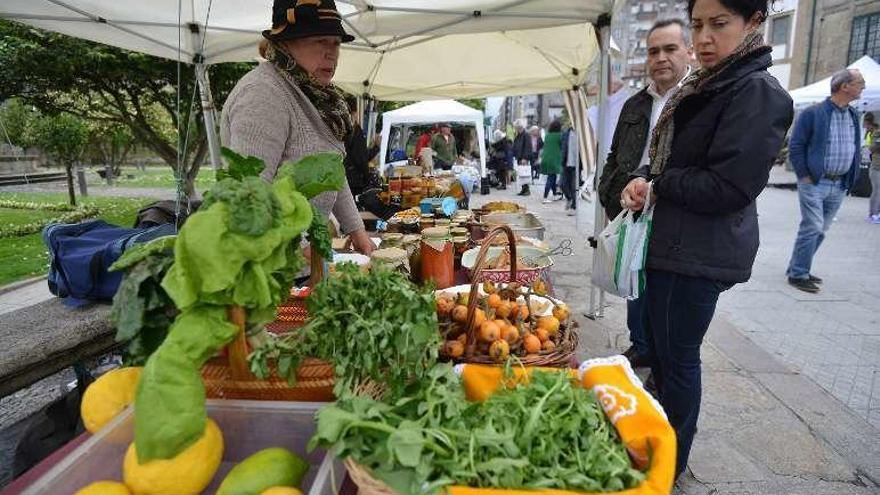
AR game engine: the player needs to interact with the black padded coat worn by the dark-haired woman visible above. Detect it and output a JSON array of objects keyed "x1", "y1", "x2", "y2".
[{"x1": 636, "y1": 48, "x2": 794, "y2": 283}]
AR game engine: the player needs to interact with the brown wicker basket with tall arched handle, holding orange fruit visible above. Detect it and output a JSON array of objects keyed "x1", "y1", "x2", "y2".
[{"x1": 456, "y1": 225, "x2": 578, "y2": 368}]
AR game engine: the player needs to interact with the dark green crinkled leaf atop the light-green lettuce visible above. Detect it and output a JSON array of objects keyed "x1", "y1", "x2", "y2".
[{"x1": 202, "y1": 177, "x2": 279, "y2": 236}]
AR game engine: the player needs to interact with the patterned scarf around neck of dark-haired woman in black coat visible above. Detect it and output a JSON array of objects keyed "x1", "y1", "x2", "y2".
[{"x1": 648, "y1": 30, "x2": 765, "y2": 175}]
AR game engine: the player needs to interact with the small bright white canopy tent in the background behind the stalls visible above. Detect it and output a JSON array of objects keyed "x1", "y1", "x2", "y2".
[{"x1": 379, "y1": 100, "x2": 486, "y2": 177}]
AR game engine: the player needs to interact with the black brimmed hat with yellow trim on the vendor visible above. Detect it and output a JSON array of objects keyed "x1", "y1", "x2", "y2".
[{"x1": 263, "y1": 0, "x2": 354, "y2": 43}]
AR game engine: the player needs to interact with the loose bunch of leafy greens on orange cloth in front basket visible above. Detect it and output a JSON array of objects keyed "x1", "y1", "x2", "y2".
[{"x1": 309, "y1": 364, "x2": 645, "y2": 494}]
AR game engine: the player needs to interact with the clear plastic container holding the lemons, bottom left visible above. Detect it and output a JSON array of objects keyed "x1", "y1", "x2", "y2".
[{"x1": 21, "y1": 399, "x2": 346, "y2": 495}]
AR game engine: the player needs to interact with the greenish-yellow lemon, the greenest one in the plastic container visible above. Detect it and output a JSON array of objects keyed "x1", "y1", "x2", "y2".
[{"x1": 217, "y1": 447, "x2": 309, "y2": 495}]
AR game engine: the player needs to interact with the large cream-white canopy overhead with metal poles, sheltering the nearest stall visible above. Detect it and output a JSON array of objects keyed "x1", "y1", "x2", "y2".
[{"x1": 0, "y1": 0, "x2": 624, "y2": 315}]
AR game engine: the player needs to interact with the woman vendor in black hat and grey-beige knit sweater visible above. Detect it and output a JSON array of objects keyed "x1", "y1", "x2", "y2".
[{"x1": 220, "y1": 0, "x2": 373, "y2": 254}]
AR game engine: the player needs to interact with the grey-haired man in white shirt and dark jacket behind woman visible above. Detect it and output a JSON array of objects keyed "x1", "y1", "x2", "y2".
[{"x1": 599, "y1": 19, "x2": 692, "y2": 367}]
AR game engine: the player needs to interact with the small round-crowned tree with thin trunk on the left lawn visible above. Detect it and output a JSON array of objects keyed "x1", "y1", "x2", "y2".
[{"x1": 31, "y1": 114, "x2": 89, "y2": 206}]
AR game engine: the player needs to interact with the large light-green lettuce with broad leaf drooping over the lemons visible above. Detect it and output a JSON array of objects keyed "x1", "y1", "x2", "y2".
[{"x1": 135, "y1": 149, "x2": 345, "y2": 462}]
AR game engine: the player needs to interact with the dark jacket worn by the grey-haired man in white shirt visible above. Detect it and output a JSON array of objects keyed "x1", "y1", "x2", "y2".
[{"x1": 599, "y1": 89, "x2": 654, "y2": 219}]
